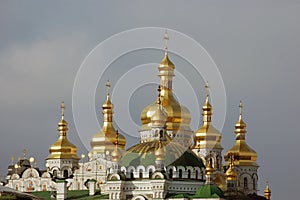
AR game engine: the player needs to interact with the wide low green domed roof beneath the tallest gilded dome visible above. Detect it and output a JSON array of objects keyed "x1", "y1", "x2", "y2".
[{"x1": 121, "y1": 141, "x2": 204, "y2": 168}]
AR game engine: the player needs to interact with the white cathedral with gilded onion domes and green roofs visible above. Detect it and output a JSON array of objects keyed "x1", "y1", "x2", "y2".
[{"x1": 6, "y1": 35, "x2": 271, "y2": 200}]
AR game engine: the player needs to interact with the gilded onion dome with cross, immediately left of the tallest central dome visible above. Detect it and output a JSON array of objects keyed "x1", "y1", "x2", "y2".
[{"x1": 91, "y1": 81, "x2": 126, "y2": 154}]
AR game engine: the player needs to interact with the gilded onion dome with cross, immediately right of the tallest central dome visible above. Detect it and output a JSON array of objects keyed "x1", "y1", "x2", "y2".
[{"x1": 193, "y1": 84, "x2": 223, "y2": 149}]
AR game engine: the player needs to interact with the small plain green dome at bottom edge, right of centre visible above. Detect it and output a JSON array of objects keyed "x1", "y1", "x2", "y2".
[{"x1": 193, "y1": 185, "x2": 224, "y2": 198}]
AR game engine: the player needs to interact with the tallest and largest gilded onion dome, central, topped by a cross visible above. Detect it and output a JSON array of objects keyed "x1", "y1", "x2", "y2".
[{"x1": 141, "y1": 34, "x2": 191, "y2": 131}]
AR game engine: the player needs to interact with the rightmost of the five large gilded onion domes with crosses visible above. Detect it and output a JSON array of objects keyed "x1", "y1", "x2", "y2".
[{"x1": 224, "y1": 102, "x2": 258, "y2": 166}]
